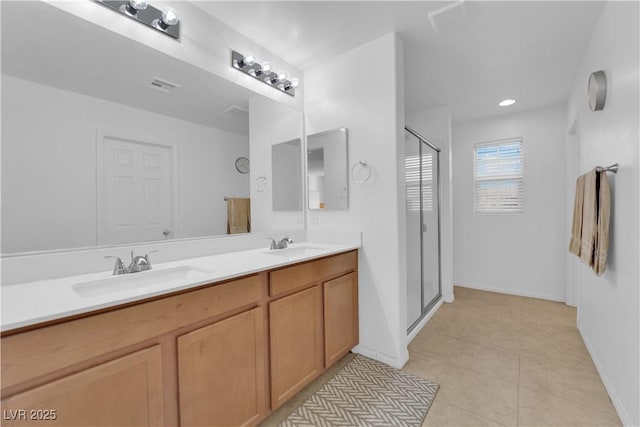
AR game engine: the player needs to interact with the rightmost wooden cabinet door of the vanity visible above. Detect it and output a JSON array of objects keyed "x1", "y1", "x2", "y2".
[{"x1": 323, "y1": 273, "x2": 358, "y2": 367}]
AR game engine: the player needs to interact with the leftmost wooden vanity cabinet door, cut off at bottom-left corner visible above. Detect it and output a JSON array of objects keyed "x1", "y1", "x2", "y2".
[{"x1": 2, "y1": 345, "x2": 164, "y2": 427}]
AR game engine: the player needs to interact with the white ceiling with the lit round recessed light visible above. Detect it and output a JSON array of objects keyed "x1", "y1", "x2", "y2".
[{"x1": 194, "y1": 1, "x2": 604, "y2": 121}]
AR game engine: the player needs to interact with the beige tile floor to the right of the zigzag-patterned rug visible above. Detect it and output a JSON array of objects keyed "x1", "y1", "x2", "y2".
[{"x1": 404, "y1": 287, "x2": 621, "y2": 427}]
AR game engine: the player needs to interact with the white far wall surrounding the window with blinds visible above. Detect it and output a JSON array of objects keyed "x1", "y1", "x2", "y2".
[{"x1": 453, "y1": 105, "x2": 573, "y2": 301}]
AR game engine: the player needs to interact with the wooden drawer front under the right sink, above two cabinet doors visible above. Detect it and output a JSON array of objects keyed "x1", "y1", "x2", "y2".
[{"x1": 269, "y1": 251, "x2": 358, "y2": 297}]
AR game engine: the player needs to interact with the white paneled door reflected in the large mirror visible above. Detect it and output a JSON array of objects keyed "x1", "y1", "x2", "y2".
[{"x1": 98, "y1": 136, "x2": 172, "y2": 244}]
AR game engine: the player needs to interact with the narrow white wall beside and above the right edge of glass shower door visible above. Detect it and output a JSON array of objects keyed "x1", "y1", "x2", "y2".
[{"x1": 406, "y1": 107, "x2": 454, "y2": 302}]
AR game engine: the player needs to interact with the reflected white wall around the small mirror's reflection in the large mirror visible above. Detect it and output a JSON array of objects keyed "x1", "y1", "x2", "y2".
[{"x1": 249, "y1": 96, "x2": 306, "y2": 234}]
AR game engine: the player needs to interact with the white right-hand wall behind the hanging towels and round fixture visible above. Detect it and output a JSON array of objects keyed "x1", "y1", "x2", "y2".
[{"x1": 568, "y1": 2, "x2": 640, "y2": 426}]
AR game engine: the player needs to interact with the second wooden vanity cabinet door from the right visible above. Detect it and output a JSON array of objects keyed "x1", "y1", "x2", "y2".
[{"x1": 269, "y1": 285, "x2": 324, "y2": 409}]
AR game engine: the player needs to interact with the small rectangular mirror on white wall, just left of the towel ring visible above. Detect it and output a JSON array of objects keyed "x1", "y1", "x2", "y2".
[{"x1": 307, "y1": 128, "x2": 349, "y2": 210}]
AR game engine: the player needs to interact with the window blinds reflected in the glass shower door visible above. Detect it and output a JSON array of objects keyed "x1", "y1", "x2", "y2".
[{"x1": 404, "y1": 153, "x2": 433, "y2": 212}]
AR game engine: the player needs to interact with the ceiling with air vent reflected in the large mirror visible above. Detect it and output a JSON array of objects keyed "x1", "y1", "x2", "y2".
[{"x1": 1, "y1": 1, "x2": 252, "y2": 135}]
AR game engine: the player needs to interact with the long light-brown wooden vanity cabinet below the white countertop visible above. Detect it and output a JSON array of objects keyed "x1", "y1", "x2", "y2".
[{"x1": 2, "y1": 247, "x2": 358, "y2": 426}]
